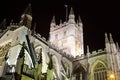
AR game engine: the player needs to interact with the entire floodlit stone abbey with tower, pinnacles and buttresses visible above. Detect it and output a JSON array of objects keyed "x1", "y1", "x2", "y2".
[{"x1": 0, "y1": 4, "x2": 120, "y2": 80}]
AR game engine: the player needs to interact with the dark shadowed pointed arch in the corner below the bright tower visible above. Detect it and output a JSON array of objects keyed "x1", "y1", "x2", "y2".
[{"x1": 72, "y1": 64, "x2": 86, "y2": 80}]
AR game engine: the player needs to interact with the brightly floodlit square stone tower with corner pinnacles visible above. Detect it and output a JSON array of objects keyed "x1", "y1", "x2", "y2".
[{"x1": 49, "y1": 8, "x2": 84, "y2": 57}]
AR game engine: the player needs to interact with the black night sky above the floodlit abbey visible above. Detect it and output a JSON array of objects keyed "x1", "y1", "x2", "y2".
[{"x1": 0, "y1": 0, "x2": 120, "y2": 51}]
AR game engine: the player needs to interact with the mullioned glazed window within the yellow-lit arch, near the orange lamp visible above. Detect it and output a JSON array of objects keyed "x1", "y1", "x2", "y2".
[{"x1": 93, "y1": 63, "x2": 107, "y2": 80}]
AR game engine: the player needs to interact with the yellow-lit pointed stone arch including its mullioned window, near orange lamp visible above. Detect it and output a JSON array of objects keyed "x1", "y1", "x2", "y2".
[{"x1": 91, "y1": 60, "x2": 107, "y2": 80}]
